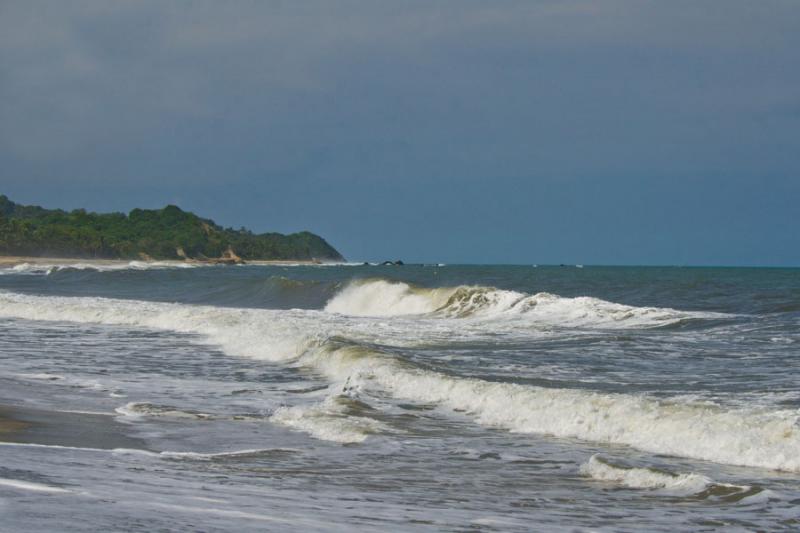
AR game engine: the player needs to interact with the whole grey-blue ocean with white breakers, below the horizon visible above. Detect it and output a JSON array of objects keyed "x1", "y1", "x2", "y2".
[{"x1": 0, "y1": 263, "x2": 800, "y2": 531}]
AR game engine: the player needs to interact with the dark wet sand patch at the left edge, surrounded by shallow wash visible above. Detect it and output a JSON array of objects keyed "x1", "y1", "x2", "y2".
[{"x1": 0, "y1": 405, "x2": 146, "y2": 449}]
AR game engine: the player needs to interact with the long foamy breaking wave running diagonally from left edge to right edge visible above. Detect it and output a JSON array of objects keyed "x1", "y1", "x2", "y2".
[{"x1": 0, "y1": 292, "x2": 800, "y2": 472}]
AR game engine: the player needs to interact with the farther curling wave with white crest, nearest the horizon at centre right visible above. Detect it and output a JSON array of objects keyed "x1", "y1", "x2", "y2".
[{"x1": 325, "y1": 279, "x2": 728, "y2": 328}]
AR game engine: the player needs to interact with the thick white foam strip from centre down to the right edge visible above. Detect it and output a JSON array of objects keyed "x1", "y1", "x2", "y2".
[{"x1": 334, "y1": 354, "x2": 800, "y2": 472}]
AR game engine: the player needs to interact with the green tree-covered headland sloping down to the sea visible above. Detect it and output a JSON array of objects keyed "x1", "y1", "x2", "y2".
[{"x1": 0, "y1": 195, "x2": 343, "y2": 261}]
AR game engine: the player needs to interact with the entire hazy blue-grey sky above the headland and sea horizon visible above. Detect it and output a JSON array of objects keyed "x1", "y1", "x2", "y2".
[{"x1": 0, "y1": 0, "x2": 800, "y2": 266}]
